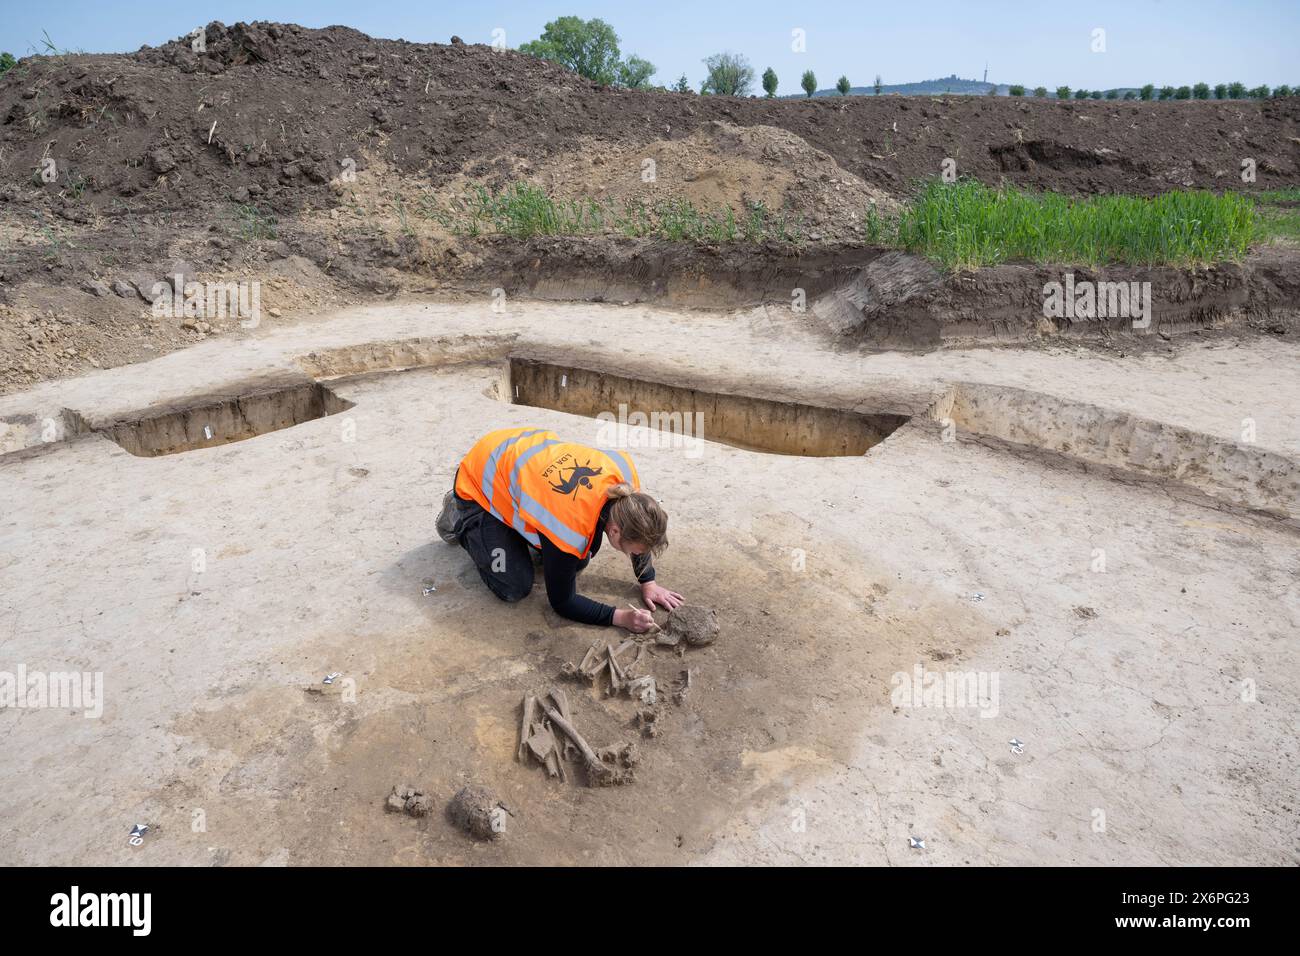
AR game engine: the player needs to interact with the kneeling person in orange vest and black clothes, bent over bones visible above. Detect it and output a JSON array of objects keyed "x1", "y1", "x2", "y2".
[{"x1": 438, "y1": 428, "x2": 683, "y2": 633}]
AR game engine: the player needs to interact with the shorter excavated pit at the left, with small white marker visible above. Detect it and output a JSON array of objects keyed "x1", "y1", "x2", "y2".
[{"x1": 88, "y1": 382, "x2": 352, "y2": 458}]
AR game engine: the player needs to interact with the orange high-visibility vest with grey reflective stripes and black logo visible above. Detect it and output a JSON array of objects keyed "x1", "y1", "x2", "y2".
[{"x1": 456, "y1": 428, "x2": 641, "y2": 558}]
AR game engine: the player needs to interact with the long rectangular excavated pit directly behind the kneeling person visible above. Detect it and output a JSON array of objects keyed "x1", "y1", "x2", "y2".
[{"x1": 502, "y1": 358, "x2": 909, "y2": 458}]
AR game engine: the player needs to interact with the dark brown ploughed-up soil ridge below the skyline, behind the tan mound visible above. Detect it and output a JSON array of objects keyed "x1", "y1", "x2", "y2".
[{"x1": 0, "y1": 23, "x2": 1300, "y2": 216}]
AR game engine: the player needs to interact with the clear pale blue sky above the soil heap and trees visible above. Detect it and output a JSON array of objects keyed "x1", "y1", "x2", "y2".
[{"x1": 0, "y1": 0, "x2": 1300, "y2": 94}]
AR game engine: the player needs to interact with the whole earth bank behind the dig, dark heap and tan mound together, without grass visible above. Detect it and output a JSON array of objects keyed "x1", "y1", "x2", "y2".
[{"x1": 0, "y1": 23, "x2": 1300, "y2": 390}]
